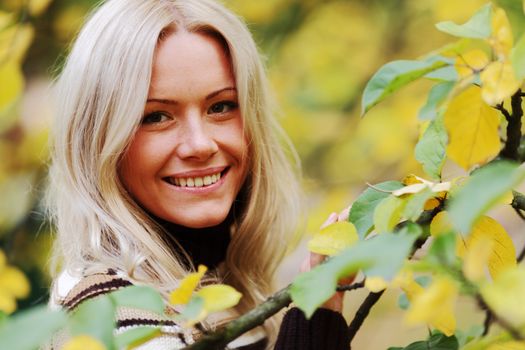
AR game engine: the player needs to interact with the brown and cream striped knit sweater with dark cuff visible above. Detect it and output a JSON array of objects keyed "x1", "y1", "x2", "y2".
[{"x1": 51, "y1": 271, "x2": 350, "y2": 350}]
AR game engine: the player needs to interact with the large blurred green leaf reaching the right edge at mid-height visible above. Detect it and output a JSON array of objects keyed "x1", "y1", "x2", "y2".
[{"x1": 448, "y1": 161, "x2": 525, "y2": 234}]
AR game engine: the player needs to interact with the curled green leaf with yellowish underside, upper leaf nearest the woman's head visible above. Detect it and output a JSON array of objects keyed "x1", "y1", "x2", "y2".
[{"x1": 361, "y1": 58, "x2": 449, "y2": 115}]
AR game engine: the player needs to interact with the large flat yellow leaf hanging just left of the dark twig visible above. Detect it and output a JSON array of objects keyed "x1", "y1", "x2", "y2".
[{"x1": 444, "y1": 86, "x2": 500, "y2": 170}]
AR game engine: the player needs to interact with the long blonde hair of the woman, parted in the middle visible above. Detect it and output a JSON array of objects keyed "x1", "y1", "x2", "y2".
[{"x1": 48, "y1": 0, "x2": 300, "y2": 342}]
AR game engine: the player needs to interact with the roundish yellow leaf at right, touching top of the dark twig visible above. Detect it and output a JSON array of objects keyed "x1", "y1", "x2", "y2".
[{"x1": 480, "y1": 61, "x2": 521, "y2": 106}]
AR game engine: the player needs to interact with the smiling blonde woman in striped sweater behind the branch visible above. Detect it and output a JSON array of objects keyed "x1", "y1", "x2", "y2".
[{"x1": 49, "y1": 0, "x2": 348, "y2": 349}]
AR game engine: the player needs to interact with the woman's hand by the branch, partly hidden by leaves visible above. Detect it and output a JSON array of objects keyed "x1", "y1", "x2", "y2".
[{"x1": 301, "y1": 207, "x2": 355, "y2": 312}]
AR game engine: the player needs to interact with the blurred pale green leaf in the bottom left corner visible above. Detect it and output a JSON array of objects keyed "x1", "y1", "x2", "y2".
[{"x1": 0, "y1": 306, "x2": 67, "y2": 350}]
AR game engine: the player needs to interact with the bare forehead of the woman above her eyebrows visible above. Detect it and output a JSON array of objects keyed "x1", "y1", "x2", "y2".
[{"x1": 150, "y1": 30, "x2": 235, "y2": 97}]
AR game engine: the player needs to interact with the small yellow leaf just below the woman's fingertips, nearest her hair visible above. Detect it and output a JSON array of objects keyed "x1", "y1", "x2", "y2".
[{"x1": 308, "y1": 221, "x2": 359, "y2": 256}]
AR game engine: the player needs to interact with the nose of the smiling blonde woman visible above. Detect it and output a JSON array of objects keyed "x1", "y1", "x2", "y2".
[{"x1": 176, "y1": 114, "x2": 219, "y2": 161}]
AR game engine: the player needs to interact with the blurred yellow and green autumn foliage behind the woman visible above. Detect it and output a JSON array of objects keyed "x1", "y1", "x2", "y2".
[{"x1": 0, "y1": 0, "x2": 525, "y2": 349}]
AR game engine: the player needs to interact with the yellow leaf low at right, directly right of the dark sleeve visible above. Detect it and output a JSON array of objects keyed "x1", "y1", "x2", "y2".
[{"x1": 405, "y1": 278, "x2": 458, "y2": 336}]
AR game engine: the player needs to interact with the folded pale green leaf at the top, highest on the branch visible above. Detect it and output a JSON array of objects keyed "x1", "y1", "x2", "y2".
[{"x1": 436, "y1": 4, "x2": 492, "y2": 39}]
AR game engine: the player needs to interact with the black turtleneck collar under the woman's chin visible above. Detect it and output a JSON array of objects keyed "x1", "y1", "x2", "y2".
[{"x1": 155, "y1": 213, "x2": 233, "y2": 269}]
